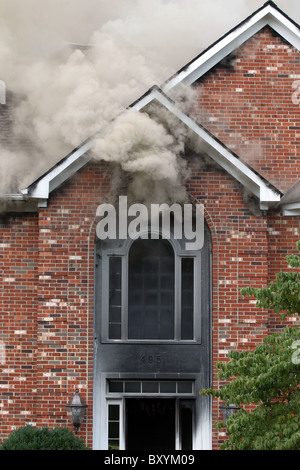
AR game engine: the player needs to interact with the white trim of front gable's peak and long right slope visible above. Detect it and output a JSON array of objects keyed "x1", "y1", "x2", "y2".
[{"x1": 133, "y1": 88, "x2": 281, "y2": 209}]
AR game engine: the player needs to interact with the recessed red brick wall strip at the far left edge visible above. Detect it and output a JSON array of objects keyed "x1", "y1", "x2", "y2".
[{"x1": 0, "y1": 214, "x2": 38, "y2": 439}]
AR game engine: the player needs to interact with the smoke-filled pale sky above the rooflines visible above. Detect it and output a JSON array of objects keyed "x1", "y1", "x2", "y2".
[{"x1": 0, "y1": 0, "x2": 300, "y2": 193}]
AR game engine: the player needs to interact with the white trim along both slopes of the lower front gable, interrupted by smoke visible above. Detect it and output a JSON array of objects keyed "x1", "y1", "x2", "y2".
[{"x1": 21, "y1": 86, "x2": 282, "y2": 210}]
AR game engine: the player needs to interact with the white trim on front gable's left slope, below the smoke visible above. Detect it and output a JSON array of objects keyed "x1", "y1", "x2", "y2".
[{"x1": 21, "y1": 140, "x2": 92, "y2": 200}]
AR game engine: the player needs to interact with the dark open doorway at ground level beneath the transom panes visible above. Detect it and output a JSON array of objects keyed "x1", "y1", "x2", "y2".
[{"x1": 126, "y1": 398, "x2": 176, "y2": 450}]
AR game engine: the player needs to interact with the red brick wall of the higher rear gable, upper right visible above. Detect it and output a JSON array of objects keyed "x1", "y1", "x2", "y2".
[{"x1": 194, "y1": 27, "x2": 300, "y2": 192}]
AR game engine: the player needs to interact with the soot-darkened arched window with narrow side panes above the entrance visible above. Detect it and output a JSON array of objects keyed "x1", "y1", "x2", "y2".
[{"x1": 96, "y1": 233, "x2": 201, "y2": 342}]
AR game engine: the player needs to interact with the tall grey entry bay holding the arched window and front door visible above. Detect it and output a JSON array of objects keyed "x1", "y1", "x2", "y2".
[{"x1": 93, "y1": 222, "x2": 212, "y2": 450}]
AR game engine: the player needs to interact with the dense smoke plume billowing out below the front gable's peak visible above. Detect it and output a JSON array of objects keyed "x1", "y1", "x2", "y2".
[{"x1": 93, "y1": 109, "x2": 190, "y2": 204}]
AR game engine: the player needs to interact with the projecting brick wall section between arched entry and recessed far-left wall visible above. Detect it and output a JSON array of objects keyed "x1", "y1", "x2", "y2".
[{"x1": 36, "y1": 164, "x2": 110, "y2": 447}]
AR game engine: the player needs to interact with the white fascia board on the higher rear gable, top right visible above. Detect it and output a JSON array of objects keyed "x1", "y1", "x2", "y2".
[{"x1": 161, "y1": 5, "x2": 300, "y2": 92}]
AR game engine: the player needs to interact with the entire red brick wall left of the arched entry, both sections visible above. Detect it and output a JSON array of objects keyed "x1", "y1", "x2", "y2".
[{"x1": 0, "y1": 164, "x2": 110, "y2": 446}]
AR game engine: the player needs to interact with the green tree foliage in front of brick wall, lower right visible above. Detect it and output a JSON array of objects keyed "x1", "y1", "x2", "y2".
[{"x1": 200, "y1": 242, "x2": 300, "y2": 450}]
